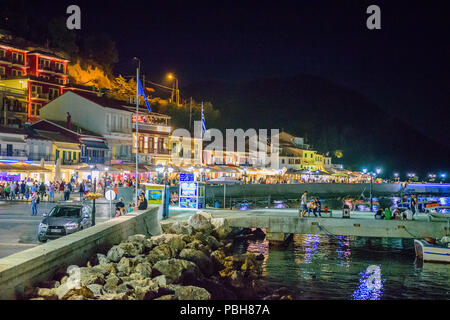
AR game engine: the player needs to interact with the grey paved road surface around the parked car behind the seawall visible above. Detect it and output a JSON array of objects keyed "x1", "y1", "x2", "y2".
[{"x1": 0, "y1": 193, "x2": 118, "y2": 258}]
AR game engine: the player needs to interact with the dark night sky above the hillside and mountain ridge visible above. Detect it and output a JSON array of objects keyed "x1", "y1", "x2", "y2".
[{"x1": 3, "y1": 0, "x2": 450, "y2": 146}]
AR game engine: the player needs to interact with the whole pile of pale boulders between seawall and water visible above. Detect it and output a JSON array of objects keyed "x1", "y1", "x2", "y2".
[{"x1": 31, "y1": 212, "x2": 291, "y2": 300}]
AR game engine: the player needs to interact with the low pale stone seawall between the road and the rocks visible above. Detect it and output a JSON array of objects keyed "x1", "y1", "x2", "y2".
[{"x1": 0, "y1": 207, "x2": 162, "y2": 300}]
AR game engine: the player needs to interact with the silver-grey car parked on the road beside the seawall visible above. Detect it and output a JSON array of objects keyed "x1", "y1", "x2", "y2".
[{"x1": 38, "y1": 203, "x2": 92, "y2": 242}]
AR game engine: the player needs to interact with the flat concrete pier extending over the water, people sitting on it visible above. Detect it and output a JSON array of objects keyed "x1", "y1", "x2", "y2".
[{"x1": 170, "y1": 209, "x2": 450, "y2": 239}]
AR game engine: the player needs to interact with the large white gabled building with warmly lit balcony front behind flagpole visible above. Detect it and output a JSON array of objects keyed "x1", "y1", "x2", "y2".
[{"x1": 41, "y1": 91, "x2": 171, "y2": 164}]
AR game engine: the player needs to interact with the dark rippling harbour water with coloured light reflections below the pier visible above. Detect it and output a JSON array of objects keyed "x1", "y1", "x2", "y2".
[{"x1": 235, "y1": 234, "x2": 450, "y2": 300}]
